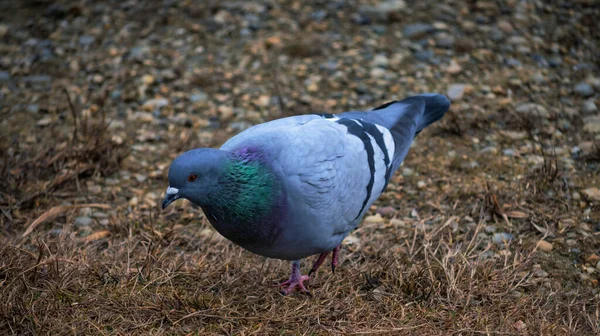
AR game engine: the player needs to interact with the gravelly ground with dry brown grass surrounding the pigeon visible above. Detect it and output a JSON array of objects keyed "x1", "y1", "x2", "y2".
[{"x1": 0, "y1": 0, "x2": 600, "y2": 335}]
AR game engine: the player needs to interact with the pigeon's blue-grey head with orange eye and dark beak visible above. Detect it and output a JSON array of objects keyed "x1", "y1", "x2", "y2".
[{"x1": 162, "y1": 148, "x2": 230, "y2": 209}]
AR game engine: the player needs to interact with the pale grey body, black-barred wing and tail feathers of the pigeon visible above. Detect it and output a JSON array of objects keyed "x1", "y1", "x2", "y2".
[{"x1": 221, "y1": 94, "x2": 450, "y2": 260}]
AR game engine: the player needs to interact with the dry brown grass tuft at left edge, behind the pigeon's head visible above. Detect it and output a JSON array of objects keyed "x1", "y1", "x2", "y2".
[{"x1": 0, "y1": 89, "x2": 128, "y2": 214}]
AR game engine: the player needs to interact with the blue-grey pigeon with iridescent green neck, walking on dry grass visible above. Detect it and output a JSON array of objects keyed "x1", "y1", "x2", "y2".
[{"x1": 162, "y1": 93, "x2": 450, "y2": 294}]
